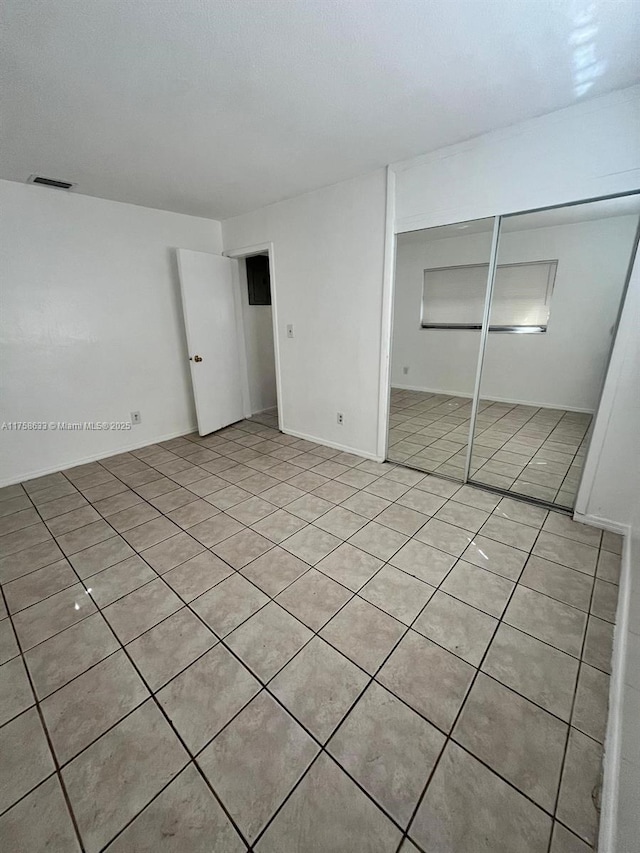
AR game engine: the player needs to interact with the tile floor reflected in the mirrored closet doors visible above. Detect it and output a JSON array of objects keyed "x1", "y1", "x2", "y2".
[{"x1": 388, "y1": 388, "x2": 592, "y2": 507}]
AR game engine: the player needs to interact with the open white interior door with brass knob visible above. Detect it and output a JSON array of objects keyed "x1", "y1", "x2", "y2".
[{"x1": 177, "y1": 249, "x2": 244, "y2": 435}]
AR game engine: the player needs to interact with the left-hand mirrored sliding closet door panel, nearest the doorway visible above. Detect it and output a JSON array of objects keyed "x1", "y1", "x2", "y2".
[{"x1": 387, "y1": 218, "x2": 494, "y2": 480}]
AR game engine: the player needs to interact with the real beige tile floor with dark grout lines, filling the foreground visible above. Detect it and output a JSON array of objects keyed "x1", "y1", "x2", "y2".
[{"x1": 0, "y1": 421, "x2": 621, "y2": 853}]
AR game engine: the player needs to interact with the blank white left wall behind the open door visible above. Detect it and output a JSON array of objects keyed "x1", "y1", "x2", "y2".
[{"x1": 0, "y1": 181, "x2": 221, "y2": 483}]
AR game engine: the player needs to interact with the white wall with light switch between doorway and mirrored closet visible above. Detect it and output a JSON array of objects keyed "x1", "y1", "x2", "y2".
[{"x1": 222, "y1": 171, "x2": 386, "y2": 455}]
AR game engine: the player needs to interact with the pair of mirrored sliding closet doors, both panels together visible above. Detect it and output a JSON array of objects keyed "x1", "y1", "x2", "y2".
[{"x1": 387, "y1": 193, "x2": 640, "y2": 509}]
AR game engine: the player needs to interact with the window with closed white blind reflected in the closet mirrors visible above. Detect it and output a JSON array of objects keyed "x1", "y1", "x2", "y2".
[{"x1": 421, "y1": 260, "x2": 558, "y2": 332}]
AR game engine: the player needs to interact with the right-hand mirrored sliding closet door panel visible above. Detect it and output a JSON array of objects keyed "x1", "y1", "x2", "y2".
[{"x1": 469, "y1": 195, "x2": 640, "y2": 508}]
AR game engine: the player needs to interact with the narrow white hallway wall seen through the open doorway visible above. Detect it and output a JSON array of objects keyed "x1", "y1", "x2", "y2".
[{"x1": 239, "y1": 259, "x2": 278, "y2": 415}]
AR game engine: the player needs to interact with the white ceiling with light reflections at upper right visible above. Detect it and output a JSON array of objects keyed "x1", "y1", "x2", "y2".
[{"x1": 0, "y1": 0, "x2": 640, "y2": 219}]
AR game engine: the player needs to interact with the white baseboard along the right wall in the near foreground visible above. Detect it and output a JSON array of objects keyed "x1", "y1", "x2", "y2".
[{"x1": 598, "y1": 527, "x2": 631, "y2": 853}]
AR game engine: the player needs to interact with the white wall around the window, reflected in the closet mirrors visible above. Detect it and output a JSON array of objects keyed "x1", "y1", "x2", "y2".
[{"x1": 392, "y1": 216, "x2": 638, "y2": 411}]
